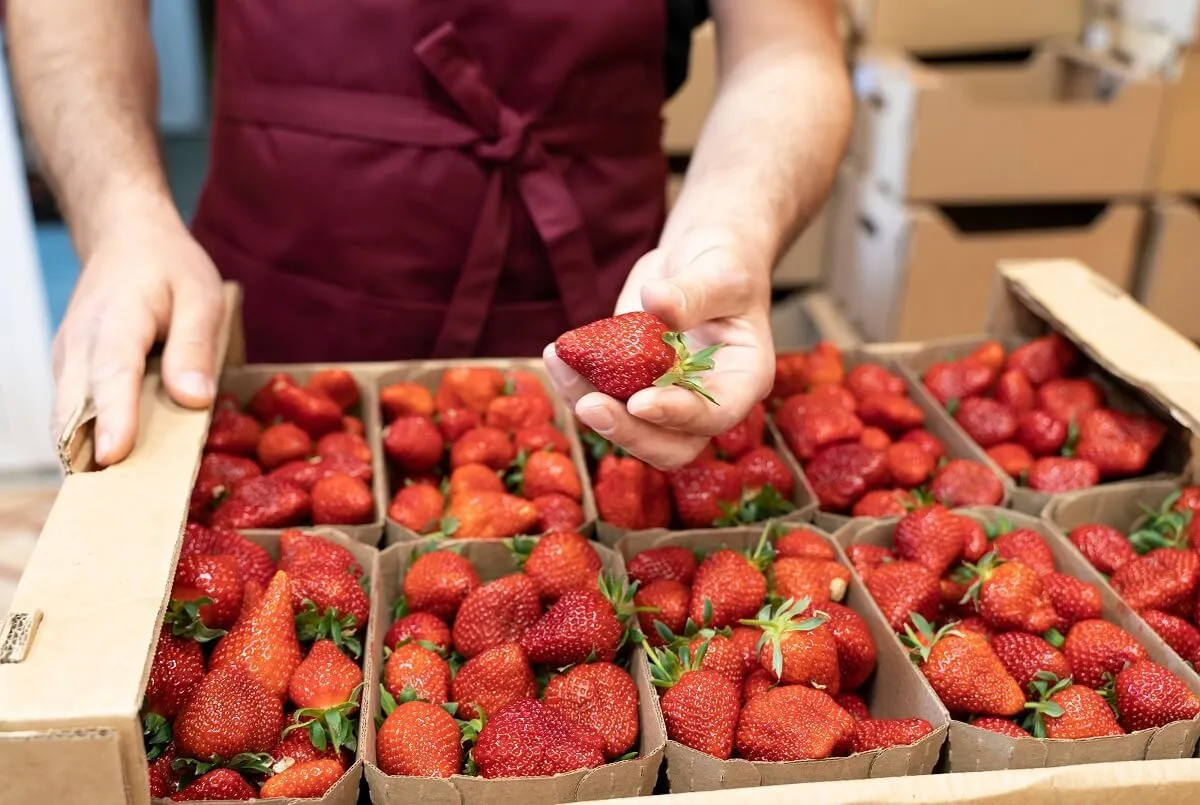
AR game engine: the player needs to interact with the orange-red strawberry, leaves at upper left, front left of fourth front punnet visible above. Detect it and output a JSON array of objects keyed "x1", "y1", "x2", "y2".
[{"x1": 900, "y1": 613, "x2": 1025, "y2": 716}]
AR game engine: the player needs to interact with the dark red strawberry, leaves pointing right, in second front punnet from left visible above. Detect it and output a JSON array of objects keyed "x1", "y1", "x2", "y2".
[{"x1": 521, "y1": 579, "x2": 632, "y2": 667}]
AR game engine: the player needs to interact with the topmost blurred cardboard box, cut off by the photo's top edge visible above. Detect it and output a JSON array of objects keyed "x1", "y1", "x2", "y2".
[{"x1": 846, "y1": 0, "x2": 1085, "y2": 53}]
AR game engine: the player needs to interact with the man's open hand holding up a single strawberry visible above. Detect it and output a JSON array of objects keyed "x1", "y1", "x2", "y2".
[{"x1": 544, "y1": 226, "x2": 775, "y2": 469}]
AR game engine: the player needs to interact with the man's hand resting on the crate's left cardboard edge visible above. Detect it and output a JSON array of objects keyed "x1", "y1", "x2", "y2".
[{"x1": 53, "y1": 201, "x2": 223, "y2": 464}]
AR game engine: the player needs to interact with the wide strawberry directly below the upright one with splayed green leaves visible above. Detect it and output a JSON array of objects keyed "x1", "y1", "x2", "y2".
[{"x1": 737, "y1": 685, "x2": 856, "y2": 763}]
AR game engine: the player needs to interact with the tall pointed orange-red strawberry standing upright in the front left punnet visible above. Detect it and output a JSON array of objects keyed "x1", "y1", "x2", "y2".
[{"x1": 207, "y1": 570, "x2": 300, "y2": 695}]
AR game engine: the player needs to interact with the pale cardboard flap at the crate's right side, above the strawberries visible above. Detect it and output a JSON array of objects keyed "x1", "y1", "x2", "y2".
[{"x1": 991, "y1": 260, "x2": 1200, "y2": 433}]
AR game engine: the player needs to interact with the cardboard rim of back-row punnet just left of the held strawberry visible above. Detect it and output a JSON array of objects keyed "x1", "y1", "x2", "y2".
[{"x1": 373, "y1": 358, "x2": 596, "y2": 545}]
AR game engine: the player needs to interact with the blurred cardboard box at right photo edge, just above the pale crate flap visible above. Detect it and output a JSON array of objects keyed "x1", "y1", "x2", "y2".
[{"x1": 1136, "y1": 200, "x2": 1200, "y2": 341}]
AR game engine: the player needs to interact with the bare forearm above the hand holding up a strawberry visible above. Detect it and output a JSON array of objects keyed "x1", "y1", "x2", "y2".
[{"x1": 662, "y1": 0, "x2": 852, "y2": 280}]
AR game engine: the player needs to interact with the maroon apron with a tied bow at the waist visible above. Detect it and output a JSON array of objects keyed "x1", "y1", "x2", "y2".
[{"x1": 193, "y1": 0, "x2": 666, "y2": 362}]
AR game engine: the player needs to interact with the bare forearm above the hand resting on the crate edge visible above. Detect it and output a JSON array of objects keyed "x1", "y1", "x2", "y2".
[{"x1": 7, "y1": 0, "x2": 172, "y2": 259}]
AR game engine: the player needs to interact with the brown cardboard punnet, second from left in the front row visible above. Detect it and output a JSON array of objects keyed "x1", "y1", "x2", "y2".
[{"x1": 364, "y1": 540, "x2": 666, "y2": 805}]
